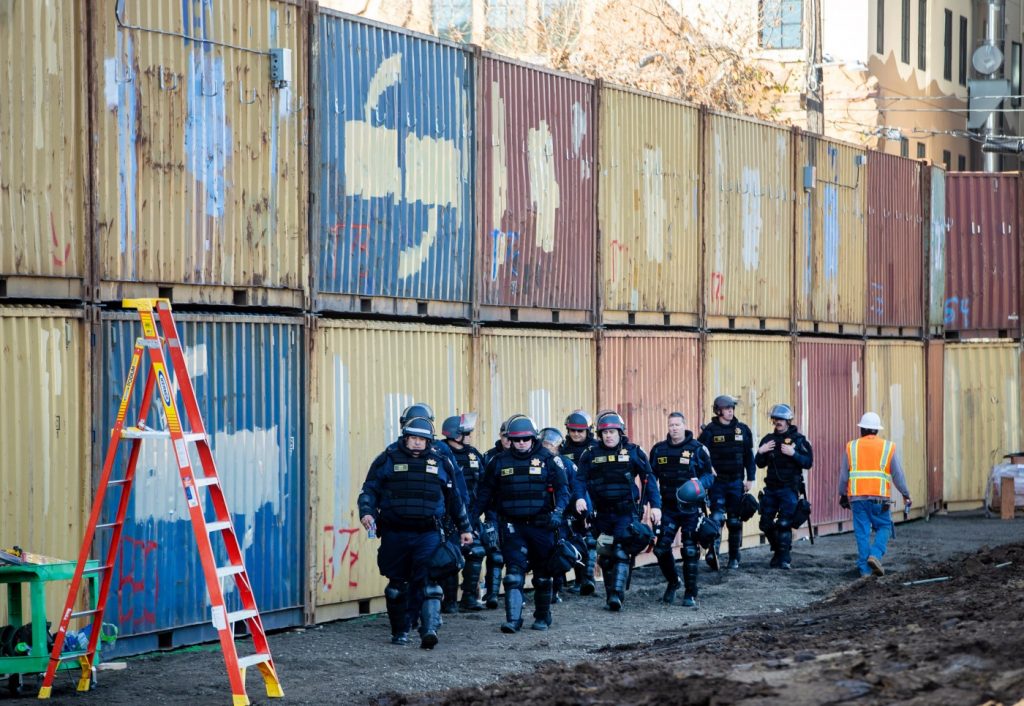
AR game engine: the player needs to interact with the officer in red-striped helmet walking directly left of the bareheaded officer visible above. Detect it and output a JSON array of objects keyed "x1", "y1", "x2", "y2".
[{"x1": 575, "y1": 412, "x2": 662, "y2": 611}]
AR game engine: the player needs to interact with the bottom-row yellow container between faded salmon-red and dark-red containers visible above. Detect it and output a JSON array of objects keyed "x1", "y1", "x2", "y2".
[{"x1": 703, "y1": 334, "x2": 794, "y2": 544}]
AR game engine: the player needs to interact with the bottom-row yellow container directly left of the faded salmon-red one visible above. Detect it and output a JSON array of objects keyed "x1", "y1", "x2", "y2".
[{"x1": 473, "y1": 329, "x2": 597, "y2": 440}]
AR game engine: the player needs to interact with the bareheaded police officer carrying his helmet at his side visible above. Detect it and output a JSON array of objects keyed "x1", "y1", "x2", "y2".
[{"x1": 650, "y1": 412, "x2": 715, "y2": 607}]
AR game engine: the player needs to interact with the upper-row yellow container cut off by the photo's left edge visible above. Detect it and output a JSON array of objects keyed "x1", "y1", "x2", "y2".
[{"x1": 0, "y1": 0, "x2": 90, "y2": 299}]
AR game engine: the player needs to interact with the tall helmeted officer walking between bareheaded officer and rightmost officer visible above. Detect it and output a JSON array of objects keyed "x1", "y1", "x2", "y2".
[{"x1": 699, "y1": 394, "x2": 757, "y2": 571}]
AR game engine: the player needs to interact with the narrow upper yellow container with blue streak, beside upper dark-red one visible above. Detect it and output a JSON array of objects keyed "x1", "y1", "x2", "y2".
[{"x1": 796, "y1": 134, "x2": 868, "y2": 334}]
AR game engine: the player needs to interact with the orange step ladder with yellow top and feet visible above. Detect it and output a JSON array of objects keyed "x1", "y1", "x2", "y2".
[{"x1": 39, "y1": 299, "x2": 284, "y2": 706}]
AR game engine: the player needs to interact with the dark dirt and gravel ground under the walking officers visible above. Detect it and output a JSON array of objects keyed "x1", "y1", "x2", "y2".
[{"x1": 12, "y1": 513, "x2": 1024, "y2": 705}]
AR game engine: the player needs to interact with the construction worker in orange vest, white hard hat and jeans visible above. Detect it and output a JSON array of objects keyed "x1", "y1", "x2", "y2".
[{"x1": 839, "y1": 412, "x2": 912, "y2": 578}]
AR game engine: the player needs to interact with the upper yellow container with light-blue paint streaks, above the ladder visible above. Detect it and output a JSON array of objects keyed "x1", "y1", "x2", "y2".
[{"x1": 89, "y1": 0, "x2": 309, "y2": 308}]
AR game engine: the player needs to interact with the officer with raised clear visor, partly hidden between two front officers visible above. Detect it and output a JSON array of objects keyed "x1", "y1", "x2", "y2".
[{"x1": 441, "y1": 413, "x2": 486, "y2": 613}]
